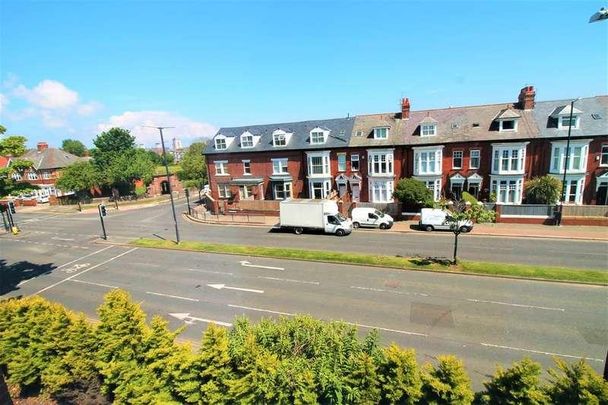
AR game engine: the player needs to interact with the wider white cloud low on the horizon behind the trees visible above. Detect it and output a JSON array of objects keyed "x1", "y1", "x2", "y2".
[{"x1": 97, "y1": 111, "x2": 217, "y2": 146}]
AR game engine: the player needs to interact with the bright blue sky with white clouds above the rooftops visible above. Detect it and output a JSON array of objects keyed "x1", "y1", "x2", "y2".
[{"x1": 0, "y1": 0, "x2": 608, "y2": 147}]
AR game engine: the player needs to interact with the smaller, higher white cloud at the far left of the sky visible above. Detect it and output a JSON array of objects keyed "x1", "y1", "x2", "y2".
[{"x1": 13, "y1": 80, "x2": 79, "y2": 110}]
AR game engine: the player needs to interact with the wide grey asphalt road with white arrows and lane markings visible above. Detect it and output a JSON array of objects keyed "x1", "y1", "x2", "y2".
[{"x1": 0, "y1": 201, "x2": 608, "y2": 388}]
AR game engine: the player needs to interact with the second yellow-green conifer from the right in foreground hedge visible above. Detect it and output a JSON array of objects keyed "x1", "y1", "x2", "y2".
[{"x1": 477, "y1": 358, "x2": 549, "y2": 405}]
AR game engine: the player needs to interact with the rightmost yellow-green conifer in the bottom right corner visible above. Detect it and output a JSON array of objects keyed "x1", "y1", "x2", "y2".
[{"x1": 547, "y1": 358, "x2": 608, "y2": 405}]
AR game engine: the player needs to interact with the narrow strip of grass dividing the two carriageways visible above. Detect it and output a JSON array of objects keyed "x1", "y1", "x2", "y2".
[{"x1": 130, "y1": 238, "x2": 608, "y2": 285}]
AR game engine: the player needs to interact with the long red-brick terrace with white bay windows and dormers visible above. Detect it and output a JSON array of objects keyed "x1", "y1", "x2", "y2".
[{"x1": 204, "y1": 86, "x2": 608, "y2": 205}]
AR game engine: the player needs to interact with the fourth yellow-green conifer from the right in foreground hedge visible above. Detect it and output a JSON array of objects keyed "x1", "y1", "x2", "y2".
[{"x1": 379, "y1": 344, "x2": 422, "y2": 404}]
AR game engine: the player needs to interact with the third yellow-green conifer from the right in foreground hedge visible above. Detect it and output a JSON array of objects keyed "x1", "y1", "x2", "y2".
[{"x1": 422, "y1": 356, "x2": 474, "y2": 405}]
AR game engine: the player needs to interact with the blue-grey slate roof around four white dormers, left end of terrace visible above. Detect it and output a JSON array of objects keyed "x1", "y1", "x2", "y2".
[{"x1": 204, "y1": 117, "x2": 355, "y2": 155}]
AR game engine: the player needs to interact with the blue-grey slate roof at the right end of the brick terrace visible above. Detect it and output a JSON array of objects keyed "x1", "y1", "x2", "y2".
[{"x1": 533, "y1": 96, "x2": 608, "y2": 138}]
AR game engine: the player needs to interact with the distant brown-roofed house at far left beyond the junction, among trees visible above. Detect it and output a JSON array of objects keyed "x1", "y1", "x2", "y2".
[{"x1": 13, "y1": 142, "x2": 90, "y2": 200}]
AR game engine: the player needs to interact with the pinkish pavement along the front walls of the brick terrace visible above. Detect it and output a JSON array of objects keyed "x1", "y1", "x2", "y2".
[{"x1": 189, "y1": 214, "x2": 608, "y2": 241}]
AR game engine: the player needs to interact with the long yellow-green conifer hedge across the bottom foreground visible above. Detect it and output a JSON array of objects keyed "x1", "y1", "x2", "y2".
[{"x1": 0, "y1": 290, "x2": 608, "y2": 404}]
